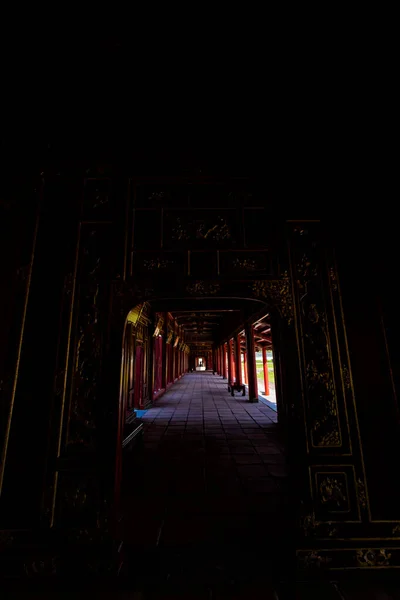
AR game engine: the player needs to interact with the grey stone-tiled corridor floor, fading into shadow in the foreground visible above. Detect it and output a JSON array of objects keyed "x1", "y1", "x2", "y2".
[{"x1": 122, "y1": 372, "x2": 286, "y2": 585}]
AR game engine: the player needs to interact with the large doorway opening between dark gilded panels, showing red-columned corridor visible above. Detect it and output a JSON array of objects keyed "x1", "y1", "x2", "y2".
[{"x1": 116, "y1": 298, "x2": 288, "y2": 580}]
